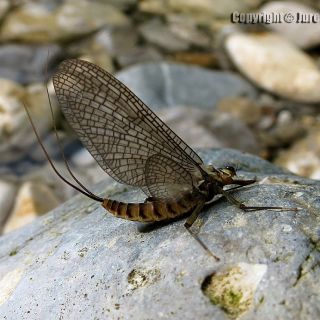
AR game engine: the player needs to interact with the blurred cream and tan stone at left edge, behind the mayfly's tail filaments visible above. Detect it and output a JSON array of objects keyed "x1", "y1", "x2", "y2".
[{"x1": 0, "y1": 79, "x2": 56, "y2": 163}]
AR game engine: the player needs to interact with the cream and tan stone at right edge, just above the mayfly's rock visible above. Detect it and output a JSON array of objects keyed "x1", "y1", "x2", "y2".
[{"x1": 275, "y1": 128, "x2": 320, "y2": 180}]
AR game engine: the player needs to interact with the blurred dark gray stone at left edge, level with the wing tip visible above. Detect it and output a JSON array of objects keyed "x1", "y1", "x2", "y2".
[{"x1": 0, "y1": 44, "x2": 61, "y2": 84}]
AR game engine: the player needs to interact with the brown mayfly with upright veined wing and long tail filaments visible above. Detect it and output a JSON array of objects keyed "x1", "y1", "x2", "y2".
[{"x1": 28, "y1": 59, "x2": 296, "y2": 260}]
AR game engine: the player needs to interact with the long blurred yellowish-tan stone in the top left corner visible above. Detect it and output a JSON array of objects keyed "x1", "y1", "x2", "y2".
[{"x1": 0, "y1": 0, "x2": 129, "y2": 43}]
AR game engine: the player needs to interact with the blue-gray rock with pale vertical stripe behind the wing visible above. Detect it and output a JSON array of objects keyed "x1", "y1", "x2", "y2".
[{"x1": 116, "y1": 63, "x2": 257, "y2": 109}]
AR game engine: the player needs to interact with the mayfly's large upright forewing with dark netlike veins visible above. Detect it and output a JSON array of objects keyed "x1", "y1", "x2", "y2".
[{"x1": 53, "y1": 59, "x2": 202, "y2": 190}]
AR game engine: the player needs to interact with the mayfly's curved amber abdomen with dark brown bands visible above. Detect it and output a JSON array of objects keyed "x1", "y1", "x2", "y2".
[{"x1": 102, "y1": 193, "x2": 199, "y2": 222}]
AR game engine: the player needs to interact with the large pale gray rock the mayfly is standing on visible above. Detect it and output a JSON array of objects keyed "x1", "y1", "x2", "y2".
[{"x1": 0, "y1": 150, "x2": 320, "y2": 320}]
